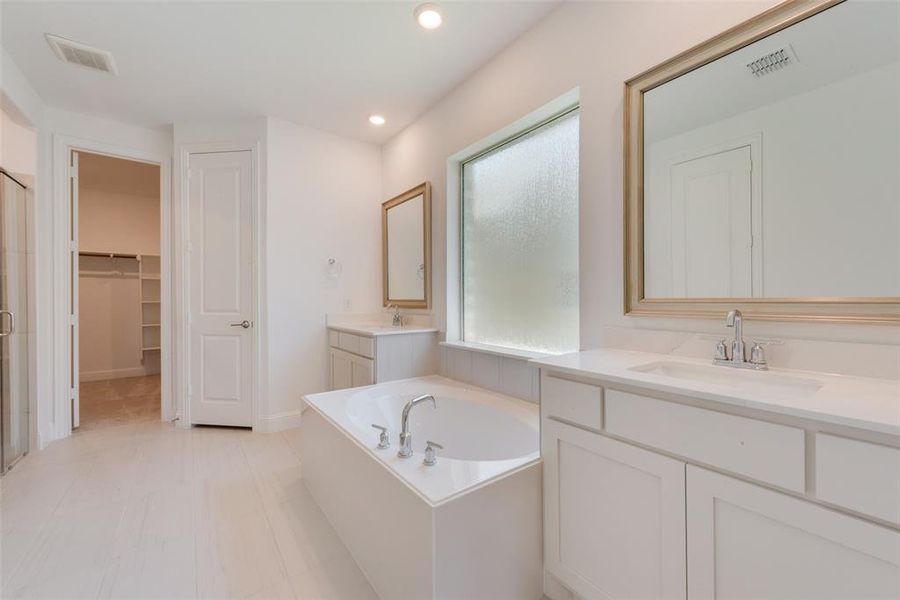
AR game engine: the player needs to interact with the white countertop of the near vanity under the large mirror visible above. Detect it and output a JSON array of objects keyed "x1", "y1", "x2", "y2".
[{"x1": 531, "y1": 349, "x2": 900, "y2": 436}]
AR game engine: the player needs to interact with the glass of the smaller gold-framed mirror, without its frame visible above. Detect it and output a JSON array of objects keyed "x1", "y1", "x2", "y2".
[{"x1": 387, "y1": 195, "x2": 425, "y2": 300}]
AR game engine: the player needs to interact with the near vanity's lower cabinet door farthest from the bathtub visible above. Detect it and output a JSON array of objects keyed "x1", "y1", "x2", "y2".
[{"x1": 687, "y1": 466, "x2": 900, "y2": 600}]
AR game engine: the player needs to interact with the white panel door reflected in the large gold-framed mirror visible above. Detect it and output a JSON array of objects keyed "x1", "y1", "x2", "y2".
[{"x1": 671, "y1": 146, "x2": 753, "y2": 298}]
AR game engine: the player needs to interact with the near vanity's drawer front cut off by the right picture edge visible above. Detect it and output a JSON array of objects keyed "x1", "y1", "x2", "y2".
[{"x1": 816, "y1": 433, "x2": 900, "y2": 524}]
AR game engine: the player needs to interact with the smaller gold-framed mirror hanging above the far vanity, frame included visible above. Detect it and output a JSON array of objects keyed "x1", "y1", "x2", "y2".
[{"x1": 381, "y1": 181, "x2": 431, "y2": 308}]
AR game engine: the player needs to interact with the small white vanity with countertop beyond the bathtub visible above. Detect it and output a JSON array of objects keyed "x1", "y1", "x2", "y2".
[{"x1": 328, "y1": 323, "x2": 438, "y2": 390}]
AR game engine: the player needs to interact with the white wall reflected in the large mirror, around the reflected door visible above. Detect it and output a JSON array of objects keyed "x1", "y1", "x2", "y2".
[{"x1": 645, "y1": 63, "x2": 900, "y2": 298}]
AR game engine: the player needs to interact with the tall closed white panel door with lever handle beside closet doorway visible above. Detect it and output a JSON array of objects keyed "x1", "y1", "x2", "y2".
[{"x1": 188, "y1": 151, "x2": 254, "y2": 427}]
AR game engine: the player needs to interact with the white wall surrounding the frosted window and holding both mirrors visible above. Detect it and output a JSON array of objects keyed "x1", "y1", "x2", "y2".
[{"x1": 382, "y1": 0, "x2": 900, "y2": 369}]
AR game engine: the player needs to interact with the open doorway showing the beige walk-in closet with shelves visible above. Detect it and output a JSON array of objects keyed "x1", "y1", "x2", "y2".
[{"x1": 72, "y1": 151, "x2": 164, "y2": 430}]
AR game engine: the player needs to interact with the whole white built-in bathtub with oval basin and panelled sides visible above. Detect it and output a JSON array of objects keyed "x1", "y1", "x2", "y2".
[{"x1": 301, "y1": 376, "x2": 542, "y2": 600}]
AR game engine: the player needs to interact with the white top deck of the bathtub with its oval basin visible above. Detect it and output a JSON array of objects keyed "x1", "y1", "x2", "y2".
[{"x1": 304, "y1": 375, "x2": 540, "y2": 506}]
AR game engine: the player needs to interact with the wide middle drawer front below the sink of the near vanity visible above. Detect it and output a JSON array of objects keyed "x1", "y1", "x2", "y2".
[{"x1": 605, "y1": 390, "x2": 806, "y2": 492}]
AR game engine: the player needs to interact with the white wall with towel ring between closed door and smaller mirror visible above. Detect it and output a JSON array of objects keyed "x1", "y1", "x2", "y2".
[{"x1": 266, "y1": 119, "x2": 384, "y2": 427}]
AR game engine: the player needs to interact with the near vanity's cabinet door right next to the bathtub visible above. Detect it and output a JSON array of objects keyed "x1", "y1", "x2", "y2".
[{"x1": 541, "y1": 419, "x2": 686, "y2": 600}]
